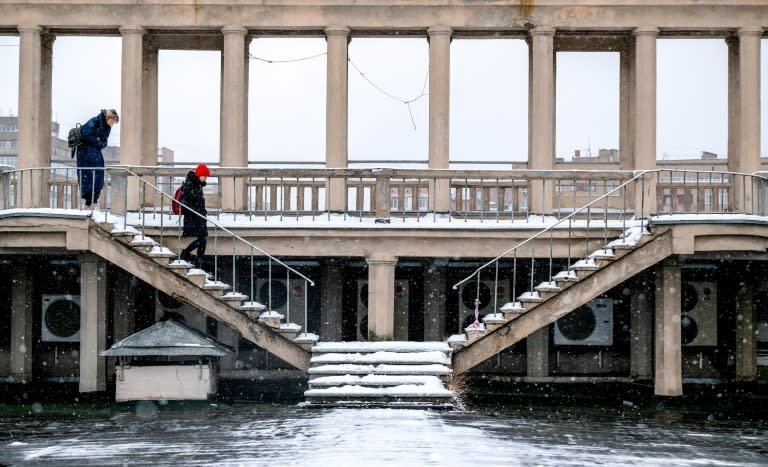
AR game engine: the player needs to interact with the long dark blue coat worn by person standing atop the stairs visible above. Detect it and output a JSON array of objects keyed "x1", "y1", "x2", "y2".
[{"x1": 77, "y1": 110, "x2": 112, "y2": 196}]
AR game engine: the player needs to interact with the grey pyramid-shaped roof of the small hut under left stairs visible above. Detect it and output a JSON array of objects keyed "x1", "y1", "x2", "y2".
[{"x1": 100, "y1": 320, "x2": 232, "y2": 357}]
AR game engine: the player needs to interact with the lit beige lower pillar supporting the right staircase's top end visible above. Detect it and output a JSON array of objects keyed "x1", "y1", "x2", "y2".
[{"x1": 655, "y1": 259, "x2": 683, "y2": 396}]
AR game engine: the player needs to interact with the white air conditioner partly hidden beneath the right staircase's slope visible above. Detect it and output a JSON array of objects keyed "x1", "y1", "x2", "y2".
[{"x1": 555, "y1": 298, "x2": 613, "y2": 345}]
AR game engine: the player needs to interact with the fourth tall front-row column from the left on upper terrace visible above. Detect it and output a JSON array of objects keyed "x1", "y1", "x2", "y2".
[{"x1": 325, "y1": 26, "x2": 349, "y2": 212}]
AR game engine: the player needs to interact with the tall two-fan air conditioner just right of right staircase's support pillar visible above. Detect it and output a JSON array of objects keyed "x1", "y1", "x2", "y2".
[{"x1": 680, "y1": 281, "x2": 717, "y2": 346}]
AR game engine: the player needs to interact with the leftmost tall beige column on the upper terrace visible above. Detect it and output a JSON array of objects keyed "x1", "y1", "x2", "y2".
[{"x1": 17, "y1": 25, "x2": 51, "y2": 207}]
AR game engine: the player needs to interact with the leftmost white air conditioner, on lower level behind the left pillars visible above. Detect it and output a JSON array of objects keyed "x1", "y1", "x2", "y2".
[{"x1": 40, "y1": 295, "x2": 80, "y2": 342}]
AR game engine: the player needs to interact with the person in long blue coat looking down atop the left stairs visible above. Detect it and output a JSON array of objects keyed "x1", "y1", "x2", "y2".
[{"x1": 77, "y1": 109, "x2": 120, "y2": 209}]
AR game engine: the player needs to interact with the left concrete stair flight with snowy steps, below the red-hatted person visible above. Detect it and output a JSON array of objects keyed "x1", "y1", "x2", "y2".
[{"x1": 88, "y1": 220, "x2": 312, "y2": 371}]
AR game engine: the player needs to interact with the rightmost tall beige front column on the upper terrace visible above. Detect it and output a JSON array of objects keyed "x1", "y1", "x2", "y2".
[{"x1": 728, "y1": 26, "x2": 763, "y2": 213}]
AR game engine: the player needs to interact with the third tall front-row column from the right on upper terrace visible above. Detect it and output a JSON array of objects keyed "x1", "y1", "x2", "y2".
[{"x1": 528, "y1": 26, "x2": 555, "y2": 214}]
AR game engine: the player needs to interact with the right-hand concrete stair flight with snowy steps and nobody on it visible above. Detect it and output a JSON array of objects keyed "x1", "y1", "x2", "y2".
[{"x1": 448, "y1": 226, "x2": 672, "y2": 374}]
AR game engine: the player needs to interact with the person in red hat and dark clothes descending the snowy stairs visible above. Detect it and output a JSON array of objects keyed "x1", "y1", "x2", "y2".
[{"x1": 180, "y1": 164, "x2": 211, "y2": 269}]
